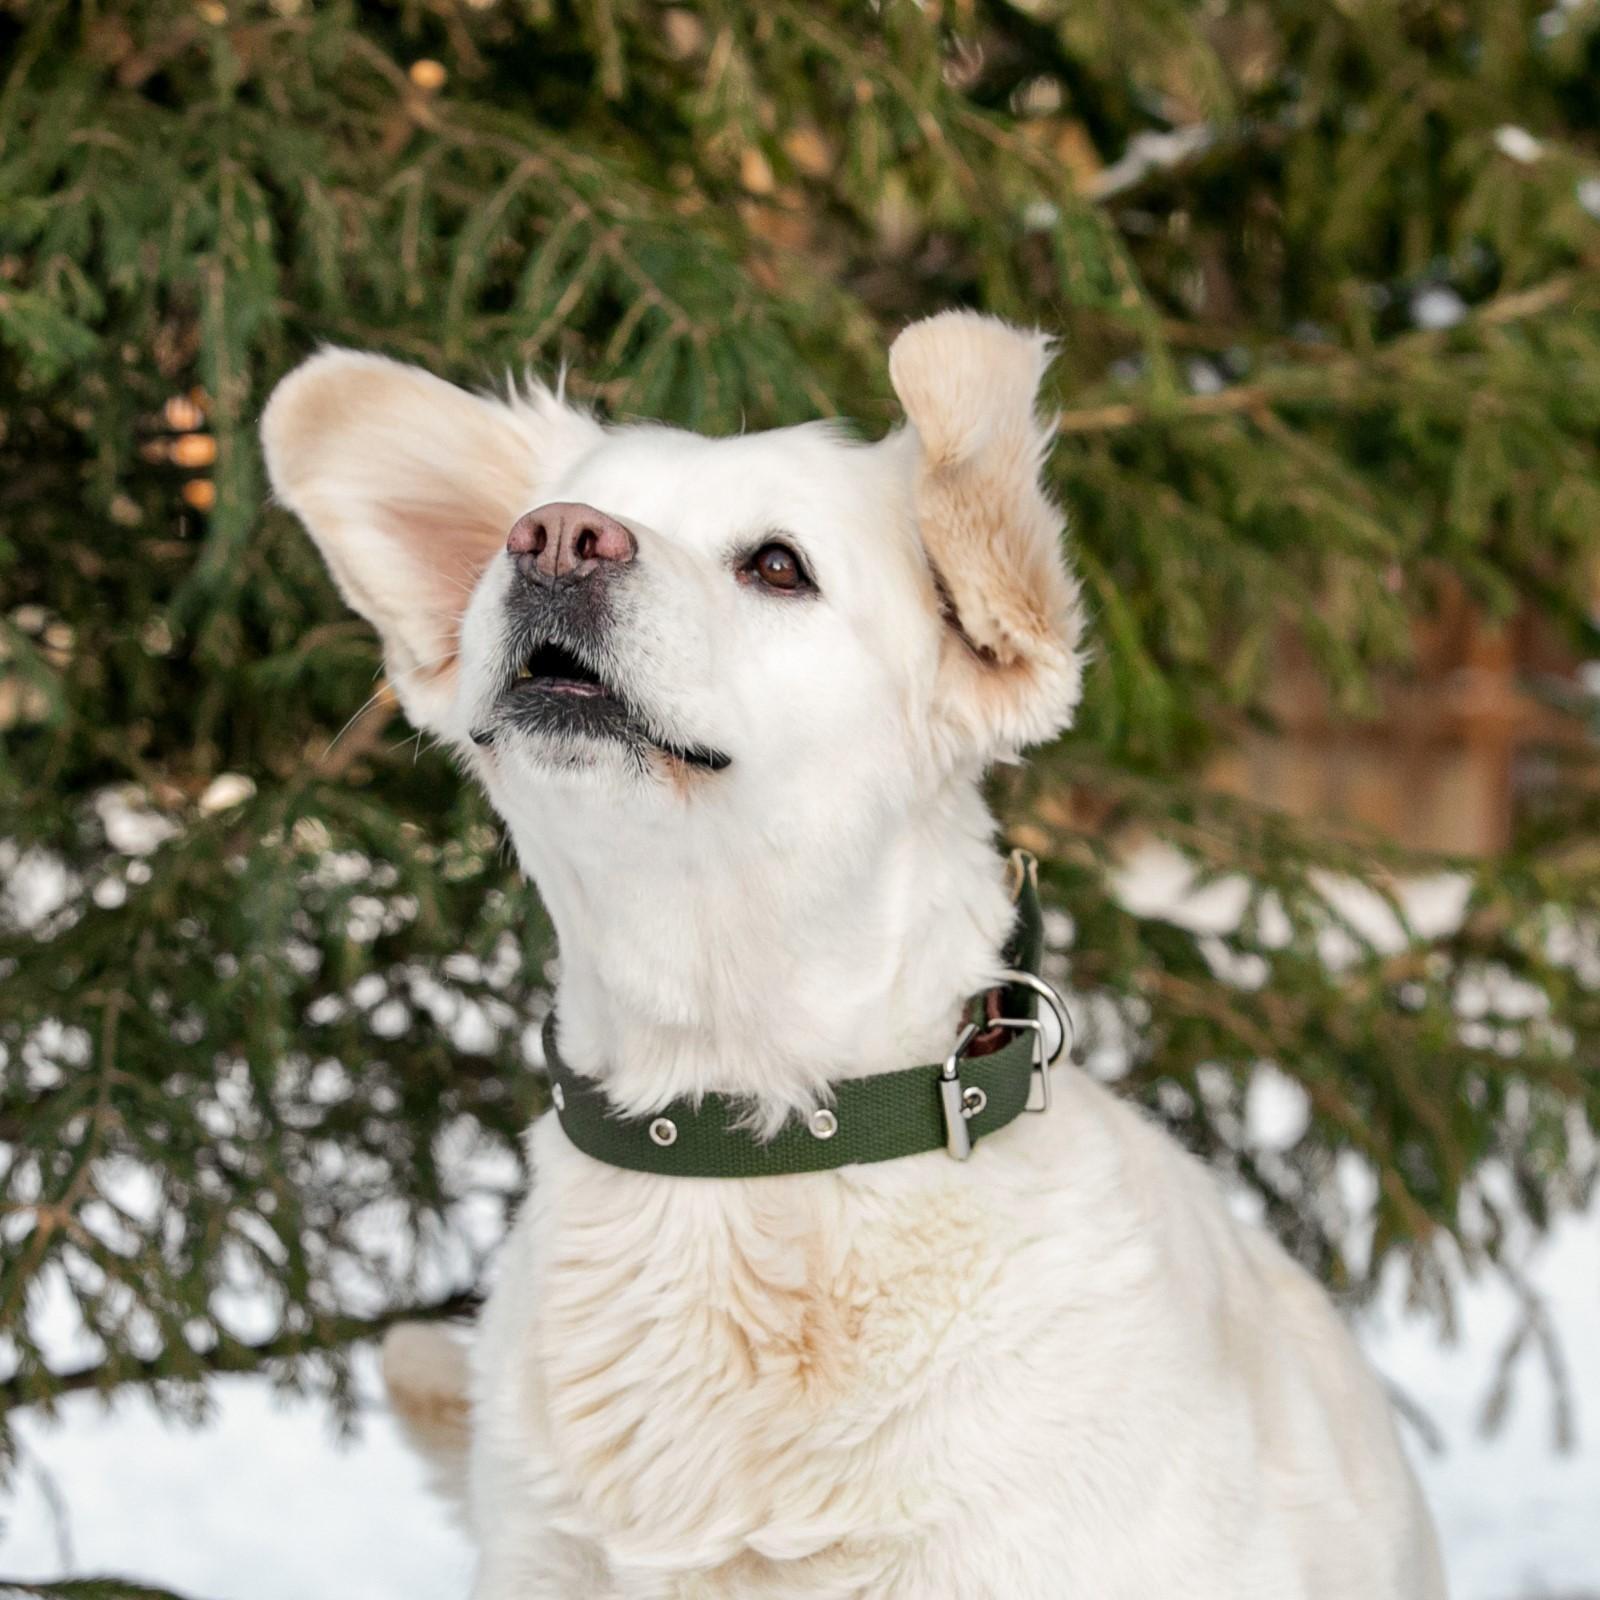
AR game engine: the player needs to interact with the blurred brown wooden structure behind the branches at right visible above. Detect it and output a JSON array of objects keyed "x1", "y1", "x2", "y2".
[{"x1": 1206, "y1": 592, "x2": 1581, "y2": 854}]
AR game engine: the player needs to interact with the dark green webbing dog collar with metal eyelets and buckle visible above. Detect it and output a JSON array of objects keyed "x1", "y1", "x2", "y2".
[{"x1": 544, "y1": 851, "x2": 1067, "y2": 1178}]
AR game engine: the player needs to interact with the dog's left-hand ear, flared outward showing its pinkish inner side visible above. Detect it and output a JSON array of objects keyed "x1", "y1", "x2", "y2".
[{"x1": 261, "y1": 350, "x2": 600, "y2": 726}]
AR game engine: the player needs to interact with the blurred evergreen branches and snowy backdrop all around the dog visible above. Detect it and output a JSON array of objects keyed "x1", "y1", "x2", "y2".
[{"x1": 0, "y1": 0, "x2": 1600, "y2": 1600}]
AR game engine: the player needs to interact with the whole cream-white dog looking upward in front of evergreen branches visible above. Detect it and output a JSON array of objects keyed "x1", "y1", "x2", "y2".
[{"x1": 264, "y1": 314, "x2": 1443, "y2": 1600}]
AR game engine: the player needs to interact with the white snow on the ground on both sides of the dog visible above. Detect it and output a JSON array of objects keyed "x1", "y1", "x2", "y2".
[{"x1": 0, "y1": 1205, "x2": 1600, "y2": 1600}]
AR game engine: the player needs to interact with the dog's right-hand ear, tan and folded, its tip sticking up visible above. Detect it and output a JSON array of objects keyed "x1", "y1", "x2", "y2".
[{"x1": 890, "y1": 312, "x2": 1083, "y2": 757}]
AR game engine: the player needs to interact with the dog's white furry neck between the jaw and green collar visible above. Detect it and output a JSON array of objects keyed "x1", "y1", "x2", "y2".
[{"x1": 512, "y1": 784, "x2": 1013, "y2": 1126}]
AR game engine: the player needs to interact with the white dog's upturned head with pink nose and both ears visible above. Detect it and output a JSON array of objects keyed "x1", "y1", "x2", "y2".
[{"x1": 262, "y1": 312, "x2": 1080, "y2": 851}]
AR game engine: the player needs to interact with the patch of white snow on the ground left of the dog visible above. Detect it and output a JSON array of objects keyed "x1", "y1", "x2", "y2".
[{"x1": 0, "y1": 1352, "x2": 472, "y2": 1600}]
